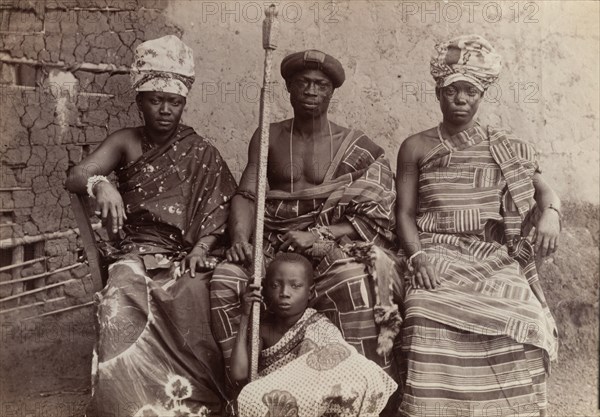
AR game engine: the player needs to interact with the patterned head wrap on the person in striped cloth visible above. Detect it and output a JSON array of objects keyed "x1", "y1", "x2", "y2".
[{"x1": 431, "y1": 35, "x2": 502, "y2": 92}]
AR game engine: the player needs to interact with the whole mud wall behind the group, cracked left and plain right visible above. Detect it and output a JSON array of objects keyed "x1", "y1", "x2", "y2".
[{"x1": 0, "y1": 0, "x2": 600, "y2": 415}]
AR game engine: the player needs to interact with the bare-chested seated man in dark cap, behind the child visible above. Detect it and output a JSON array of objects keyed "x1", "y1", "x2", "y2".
[{"x1": 211, "y1": 50, "x2": 399, "y2": 394}]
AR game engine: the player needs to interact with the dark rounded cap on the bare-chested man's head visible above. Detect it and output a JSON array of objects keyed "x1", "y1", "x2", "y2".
[{"x1": 281, "y1": 49, "x2": 346, "y2": 88}]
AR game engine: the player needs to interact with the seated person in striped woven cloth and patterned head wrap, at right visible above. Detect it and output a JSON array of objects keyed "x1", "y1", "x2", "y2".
[{"x1": 396, "y1": 35, "x2": 560, "y2": 416}]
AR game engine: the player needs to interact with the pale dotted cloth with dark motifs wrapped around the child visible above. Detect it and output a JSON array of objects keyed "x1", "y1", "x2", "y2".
[{"x1": 237, "y1": 308, "x2": 397, "y2": 417}]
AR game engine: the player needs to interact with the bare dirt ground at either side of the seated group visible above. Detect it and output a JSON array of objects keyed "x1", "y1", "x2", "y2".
[{"x1": 0, "y1": 308, "x2": 600, "y2": 417}]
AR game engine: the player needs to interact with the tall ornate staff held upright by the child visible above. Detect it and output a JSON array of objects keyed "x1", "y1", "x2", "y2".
[{"x1": 250, "y1": 4, "x2": 279, "y2": 381}]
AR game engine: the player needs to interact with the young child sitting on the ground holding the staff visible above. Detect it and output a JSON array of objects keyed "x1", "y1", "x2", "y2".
[{"x1": 230, "y1": 253, "x2": 397, "y2": 417}]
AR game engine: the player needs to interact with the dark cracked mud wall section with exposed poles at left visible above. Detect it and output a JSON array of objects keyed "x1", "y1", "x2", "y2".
[{"x1": 0, "y1": 0, "x2": 181, "y2": 311}]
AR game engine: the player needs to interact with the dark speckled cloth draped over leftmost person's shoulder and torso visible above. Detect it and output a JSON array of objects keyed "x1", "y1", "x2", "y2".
[{"x1": 116, "y1": 125, "x2": 236, "y2": 254}]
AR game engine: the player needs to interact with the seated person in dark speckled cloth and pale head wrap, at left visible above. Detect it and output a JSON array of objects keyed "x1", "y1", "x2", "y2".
[{"x1": 66, "y1": 36, "x2": 236, "y2": 416}]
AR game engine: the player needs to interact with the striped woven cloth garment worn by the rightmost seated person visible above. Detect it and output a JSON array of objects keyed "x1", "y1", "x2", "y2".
[{"x1": 400, "y1": 125, "x2": 558, "y2": 416}]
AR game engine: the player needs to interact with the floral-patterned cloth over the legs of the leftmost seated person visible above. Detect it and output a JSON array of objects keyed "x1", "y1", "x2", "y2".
[{"x1": 91, "y1": 255, "x2": 224, "y2": 417}]
